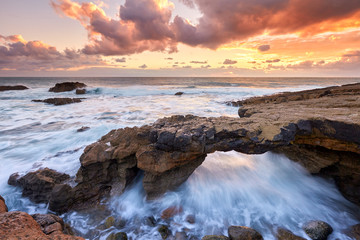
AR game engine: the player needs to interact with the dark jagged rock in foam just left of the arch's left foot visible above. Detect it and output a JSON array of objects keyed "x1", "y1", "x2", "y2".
[{"x1": 8, "y1": 168, "x2": 70, "y2": 203}]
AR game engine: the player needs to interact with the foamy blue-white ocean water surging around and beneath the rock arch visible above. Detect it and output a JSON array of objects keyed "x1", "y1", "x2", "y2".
[{"x1": 0, "y1": 77, "x2": 360, "y2": 239}]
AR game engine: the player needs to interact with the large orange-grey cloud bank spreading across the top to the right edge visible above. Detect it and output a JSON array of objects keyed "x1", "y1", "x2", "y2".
[{"x1": 52, "y1": 0, "x2": 360, "y2": 55}]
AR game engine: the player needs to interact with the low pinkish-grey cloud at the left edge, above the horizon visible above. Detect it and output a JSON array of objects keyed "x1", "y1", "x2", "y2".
[{"x1": 0, "y1": 35, "x2": 102, "y2": 71}]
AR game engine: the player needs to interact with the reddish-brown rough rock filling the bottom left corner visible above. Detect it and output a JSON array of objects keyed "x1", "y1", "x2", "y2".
[{"x1": 0, "y1": 211, "x2": 84, "y2": 240}]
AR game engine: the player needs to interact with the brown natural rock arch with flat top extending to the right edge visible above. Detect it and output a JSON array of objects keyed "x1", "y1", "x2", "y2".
[{"x1": 7, "y1": 85, "x2": 360, "y2": 212}]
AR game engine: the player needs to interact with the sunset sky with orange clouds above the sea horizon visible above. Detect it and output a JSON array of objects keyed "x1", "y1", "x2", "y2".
[{"x1": 0, "y1": 0, "x2": 360, "y2": 77}]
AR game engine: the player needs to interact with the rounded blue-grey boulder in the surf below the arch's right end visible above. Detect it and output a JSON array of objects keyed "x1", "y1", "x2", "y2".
[{"x1": 302, "y1": 221, "x2": 333, "y2": 240}]
